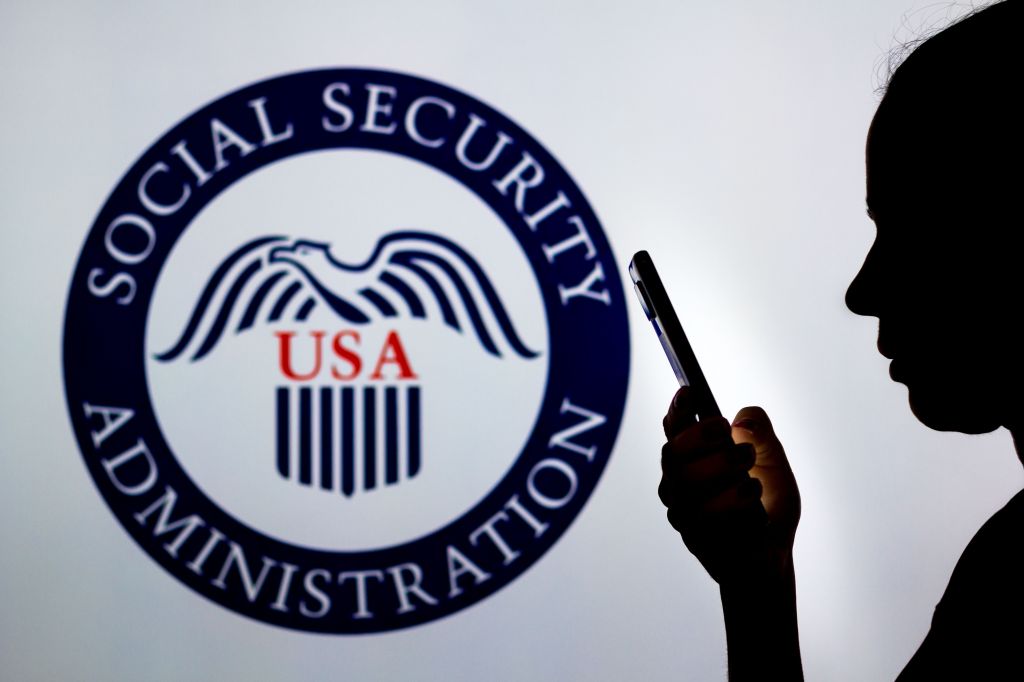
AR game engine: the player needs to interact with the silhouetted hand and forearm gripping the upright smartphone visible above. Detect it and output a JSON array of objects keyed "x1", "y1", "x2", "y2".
[{"x1": 658, "y1": 388, "x2": 803, "y2": 682}]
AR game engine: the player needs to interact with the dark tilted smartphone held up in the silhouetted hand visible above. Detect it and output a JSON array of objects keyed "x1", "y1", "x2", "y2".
[{"x1": 630, "y1": 251, "x2": 722, "y2": 419}]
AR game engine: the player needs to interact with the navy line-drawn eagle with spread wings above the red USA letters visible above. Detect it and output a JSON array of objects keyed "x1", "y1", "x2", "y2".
[{"x1": 156, "y1": 230, "x2": 538, "y2": 363}]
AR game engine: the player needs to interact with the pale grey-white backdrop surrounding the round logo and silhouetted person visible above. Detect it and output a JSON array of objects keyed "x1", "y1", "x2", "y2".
[{"x1": 0, "y1": 0, "x2": 1021, "y2": 680}]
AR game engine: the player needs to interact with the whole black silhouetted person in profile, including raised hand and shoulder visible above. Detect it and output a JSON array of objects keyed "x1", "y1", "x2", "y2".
[{"x1": 658, "y1": 0, "x2": 1024, "y2": 680}]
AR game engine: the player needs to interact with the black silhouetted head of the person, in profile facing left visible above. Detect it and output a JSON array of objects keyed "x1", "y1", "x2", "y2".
[{"x1": 846, "y1": 0, "x2": 1024, "y2": 433}]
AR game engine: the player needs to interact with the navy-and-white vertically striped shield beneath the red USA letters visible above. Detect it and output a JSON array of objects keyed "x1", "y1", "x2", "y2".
[{"x1": 274, "y1": 386, "x2": 422, "y2": 497}]
